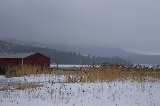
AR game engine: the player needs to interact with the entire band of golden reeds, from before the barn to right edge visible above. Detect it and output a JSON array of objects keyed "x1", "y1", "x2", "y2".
[{"x1": 6, "y1": 66, "x2": 160, "y2": 83}]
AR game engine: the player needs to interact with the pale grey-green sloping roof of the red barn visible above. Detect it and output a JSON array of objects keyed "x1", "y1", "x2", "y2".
[{"x1": 0, "y1": 53, "x2": 36, "y2": 58}]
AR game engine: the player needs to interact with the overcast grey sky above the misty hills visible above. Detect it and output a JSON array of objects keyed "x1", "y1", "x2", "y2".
[{"x1": 0, "y1": 0, "x2": 160, "y2": 55}]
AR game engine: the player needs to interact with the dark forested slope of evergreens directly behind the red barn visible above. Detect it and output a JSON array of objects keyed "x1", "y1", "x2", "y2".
[{"x1": 0, "y1": 41, "x2": 131, "y2": 65}]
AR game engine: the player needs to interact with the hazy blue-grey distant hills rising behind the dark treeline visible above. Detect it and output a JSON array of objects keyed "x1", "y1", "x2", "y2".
[{"x1": 3, "y1": 39, "x2": 160, "y2": 65}]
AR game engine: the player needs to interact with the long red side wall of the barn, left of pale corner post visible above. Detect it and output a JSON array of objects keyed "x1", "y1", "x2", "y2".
[{"x1": 0, "y1": 58, "x2": 22, "y2": 66}]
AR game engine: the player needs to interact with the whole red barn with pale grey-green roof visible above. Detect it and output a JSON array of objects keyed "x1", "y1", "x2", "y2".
[{"x1": 0, "y1": 53, "x2": 50, "y2": 67}]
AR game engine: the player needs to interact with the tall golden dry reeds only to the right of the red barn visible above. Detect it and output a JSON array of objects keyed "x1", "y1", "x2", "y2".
[{"x1": 52, "y1": 66, "x2": 160, "y2": 83}]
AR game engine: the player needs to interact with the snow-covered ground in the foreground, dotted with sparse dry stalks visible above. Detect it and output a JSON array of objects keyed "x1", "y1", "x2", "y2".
[{"x1": 0, "y1": 75, "x2": 160, "y2": 106}]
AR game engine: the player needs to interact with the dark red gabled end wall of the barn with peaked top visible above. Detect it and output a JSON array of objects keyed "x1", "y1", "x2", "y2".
[{"x1": 23, "y1": 53, "x2": 50, "y2": 67}]
